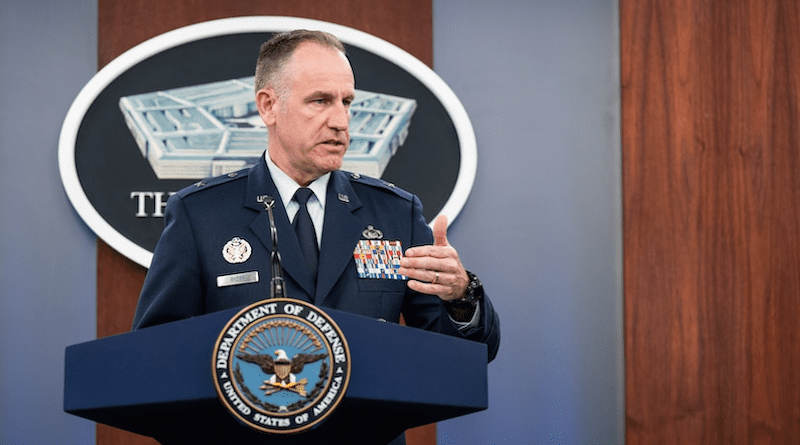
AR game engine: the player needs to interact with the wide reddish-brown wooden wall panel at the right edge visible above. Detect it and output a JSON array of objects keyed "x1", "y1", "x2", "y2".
[{"x1": 620, "y1": 0, "x2": 800, "y2": 445}]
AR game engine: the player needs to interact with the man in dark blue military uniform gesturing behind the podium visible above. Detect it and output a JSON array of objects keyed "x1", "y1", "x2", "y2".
[{"x1": 133, "y1": 30, "x2": 500, "y2": 442}]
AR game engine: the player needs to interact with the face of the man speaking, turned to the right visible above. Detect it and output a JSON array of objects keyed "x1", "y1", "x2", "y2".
[{"x1": 256, "y1": 42, "x2": 355, "y2": 185}]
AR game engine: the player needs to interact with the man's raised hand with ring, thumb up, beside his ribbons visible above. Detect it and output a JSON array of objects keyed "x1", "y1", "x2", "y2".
[{"x1": 397, "y1": 215, "x2": 469, "y2": 301}]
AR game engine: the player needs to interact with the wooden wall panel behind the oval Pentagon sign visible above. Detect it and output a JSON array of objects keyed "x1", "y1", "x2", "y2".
[{"x1": 97, "y1": 0, "x2": 436, "y2": 445}]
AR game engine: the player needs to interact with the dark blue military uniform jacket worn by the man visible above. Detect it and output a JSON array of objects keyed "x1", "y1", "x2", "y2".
[{"x1": 133, "y1": 157, "x2": 500, "y2": 360}]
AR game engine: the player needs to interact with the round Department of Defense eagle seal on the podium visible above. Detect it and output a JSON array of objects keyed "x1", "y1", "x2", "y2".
[{"x1": 212, "y1": 298, "x2": 350, "y2": 434}]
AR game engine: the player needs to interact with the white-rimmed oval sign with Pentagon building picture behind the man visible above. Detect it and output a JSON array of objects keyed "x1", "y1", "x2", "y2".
[{"x1": 58, "y1": 16, "x2": 478, "y2": 267}]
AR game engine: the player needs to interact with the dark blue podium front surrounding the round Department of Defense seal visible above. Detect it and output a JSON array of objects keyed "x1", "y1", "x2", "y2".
[{"x1": 64, "y1": 308, "x2": 488, "y2": 445}]
